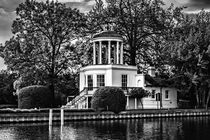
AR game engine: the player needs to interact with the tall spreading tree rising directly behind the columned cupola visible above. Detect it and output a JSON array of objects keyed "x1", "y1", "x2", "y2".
[{"x1": 88, "y1": 0, "x2": 182, "y2": 70}]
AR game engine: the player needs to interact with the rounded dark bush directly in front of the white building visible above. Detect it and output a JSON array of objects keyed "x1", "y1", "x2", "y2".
[{"x1": 91, "y1": 87, "x2": 126, "y2": 113}]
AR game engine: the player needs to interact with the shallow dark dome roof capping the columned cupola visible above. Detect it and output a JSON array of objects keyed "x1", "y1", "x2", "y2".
[{"x1": 93, "y1": 31, "x2": 122, "y2": 39}]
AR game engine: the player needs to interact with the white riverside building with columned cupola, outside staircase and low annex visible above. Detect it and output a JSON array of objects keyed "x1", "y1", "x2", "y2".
[{"x1": 67, "y1": 31, "x2": 177, "y2": 109}]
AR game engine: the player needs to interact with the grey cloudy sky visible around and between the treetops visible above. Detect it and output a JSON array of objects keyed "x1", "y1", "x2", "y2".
[{"x1": 0, "y1": 0, "x2": 210, "y2": 69}]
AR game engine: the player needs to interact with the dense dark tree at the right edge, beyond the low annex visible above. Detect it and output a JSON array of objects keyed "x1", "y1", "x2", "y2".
[{"x1": 168, "y1": 11, "x2": 210, "y2": 107}]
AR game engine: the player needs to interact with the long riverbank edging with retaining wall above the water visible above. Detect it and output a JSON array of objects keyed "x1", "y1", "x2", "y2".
[{"x1": 0, "y1": 109, "x2": 210, "y2": 123}]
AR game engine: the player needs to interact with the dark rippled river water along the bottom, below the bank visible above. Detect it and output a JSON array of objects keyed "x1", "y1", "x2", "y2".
[{"x1": 0, "y1": 117, "x2": 210, "y2": 140}]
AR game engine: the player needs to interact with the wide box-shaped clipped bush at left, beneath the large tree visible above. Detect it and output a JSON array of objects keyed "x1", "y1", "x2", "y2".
[{"x1": 18, "y1": 85, "x2": 52, "y2": 109}]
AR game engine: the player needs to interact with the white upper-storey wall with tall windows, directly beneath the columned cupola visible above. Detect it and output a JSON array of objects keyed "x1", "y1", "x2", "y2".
[{"x1": 79, "y1": 65, "x2": 137, "y2": 91}]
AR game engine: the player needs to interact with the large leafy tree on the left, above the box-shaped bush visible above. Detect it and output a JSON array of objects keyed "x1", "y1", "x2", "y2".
[{"x1": 1, "y1": 0, "x2": 86, "y2": 105}]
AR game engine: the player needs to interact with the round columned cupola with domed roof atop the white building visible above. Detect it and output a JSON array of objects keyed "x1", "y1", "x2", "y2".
[{"x1": 92, "y1": 30, "x2": 123, "y2": 65}]
